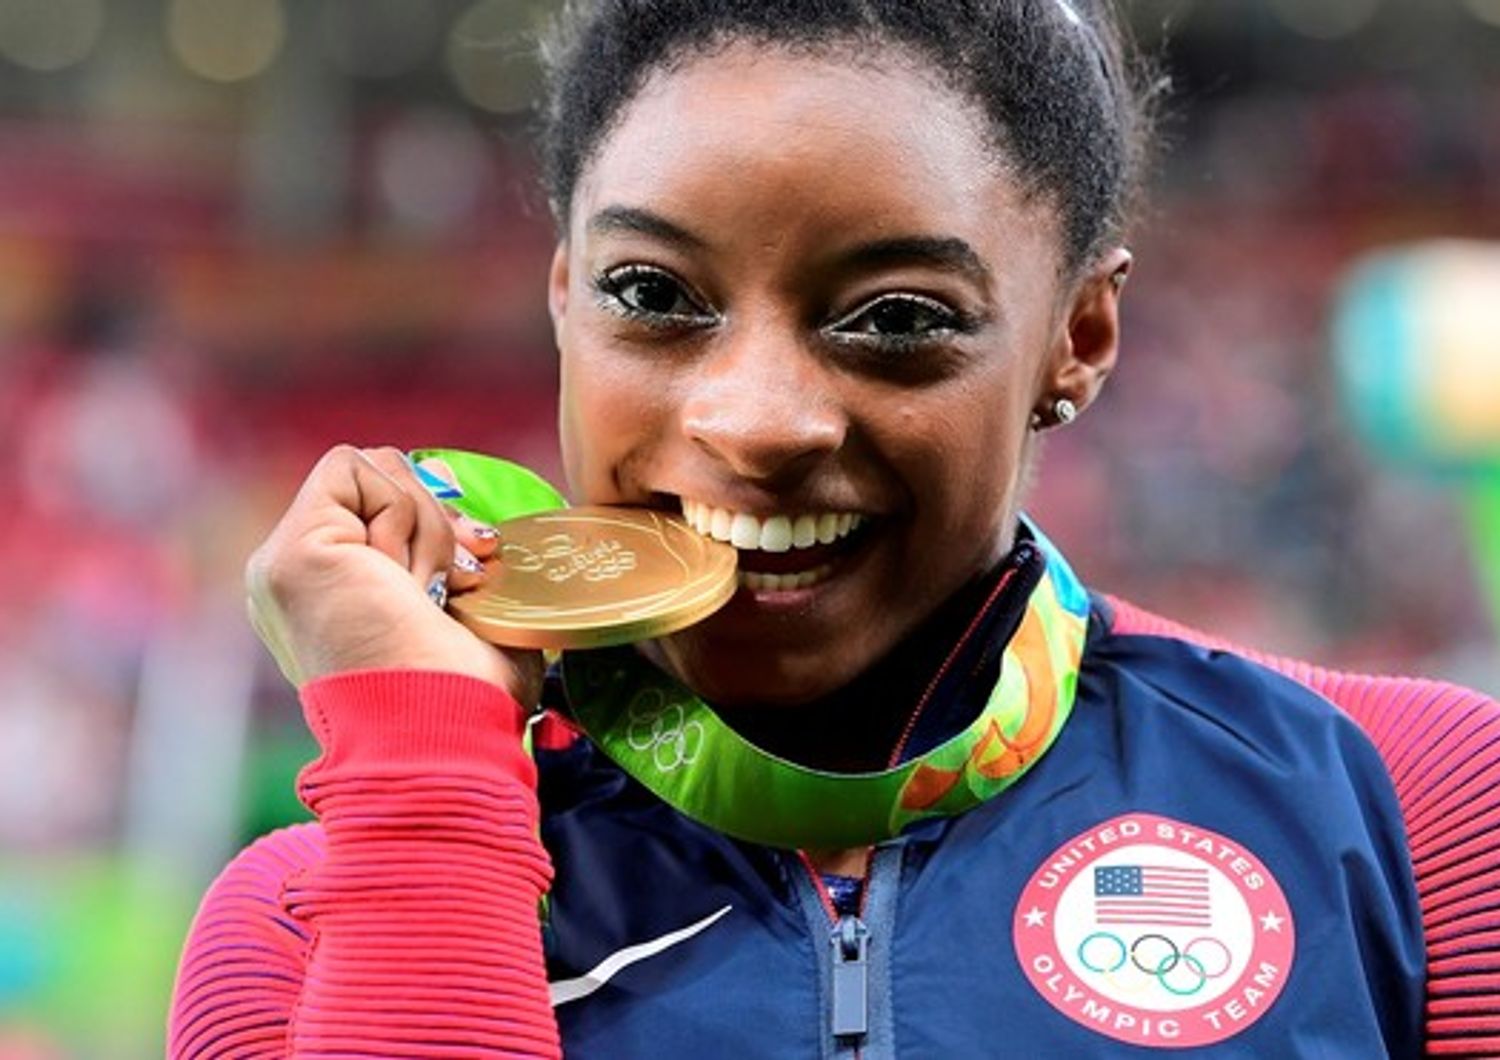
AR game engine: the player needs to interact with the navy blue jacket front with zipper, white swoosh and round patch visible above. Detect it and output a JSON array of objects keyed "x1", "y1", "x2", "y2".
[{"x1": 537, "y1": 598, "x2": 1428, "y2": 1060}]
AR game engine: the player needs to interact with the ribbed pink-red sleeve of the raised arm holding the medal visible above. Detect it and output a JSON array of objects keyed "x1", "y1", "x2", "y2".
[{"x1": 168, "y1": 672, "x2": 561, "y2": 1059}]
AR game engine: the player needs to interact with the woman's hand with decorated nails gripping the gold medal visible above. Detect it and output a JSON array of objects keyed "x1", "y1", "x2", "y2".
[{"x1": 246, "y1": 445, "x2": 543, "y2": 708}]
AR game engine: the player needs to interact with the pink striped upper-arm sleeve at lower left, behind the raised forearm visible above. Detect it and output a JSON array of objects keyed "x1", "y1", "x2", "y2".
[{"x1": 168, "y1": 825, "x2": 326, "y2": 1057}]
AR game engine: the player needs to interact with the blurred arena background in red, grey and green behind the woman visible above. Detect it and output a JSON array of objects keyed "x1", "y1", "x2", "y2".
[{"x1": 0, "y1": 0, "x2": 1500, "y2": 1060}]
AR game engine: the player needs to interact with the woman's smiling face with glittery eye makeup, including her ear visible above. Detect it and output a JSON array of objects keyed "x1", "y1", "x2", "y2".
[{"x1": 551, "y1": 45, "x2": 1115, "y2": 705}]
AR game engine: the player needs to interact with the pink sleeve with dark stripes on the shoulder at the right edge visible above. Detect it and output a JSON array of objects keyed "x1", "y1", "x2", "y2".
[{"x1": 1098, "y1": 597, "x2": 1500, "y2": 1056}]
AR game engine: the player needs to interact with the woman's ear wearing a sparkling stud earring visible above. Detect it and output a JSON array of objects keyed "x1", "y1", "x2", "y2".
[{"x1": 1034, "y1": 247, "x2": 1133, "y2": 427}]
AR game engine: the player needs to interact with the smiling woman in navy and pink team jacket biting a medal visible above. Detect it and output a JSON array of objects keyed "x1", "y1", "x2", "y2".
[{"x1": 171, "y1": 0, "x2": 1497, "y2": 1059}]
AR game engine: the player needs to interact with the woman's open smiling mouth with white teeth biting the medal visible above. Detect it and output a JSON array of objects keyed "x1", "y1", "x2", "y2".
[{"x1": 681, "y1": 498, "x2": 869, "y2": 592}]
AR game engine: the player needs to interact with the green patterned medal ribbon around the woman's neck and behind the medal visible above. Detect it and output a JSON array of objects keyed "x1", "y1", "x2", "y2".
[{"x1": 413, "y1": 450, "x2": 1089, "y2": 850}]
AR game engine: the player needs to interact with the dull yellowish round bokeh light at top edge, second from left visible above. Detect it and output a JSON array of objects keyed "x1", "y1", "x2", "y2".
[{"x1": 167, "y1": 0, "x2": 287, "y2": 82}]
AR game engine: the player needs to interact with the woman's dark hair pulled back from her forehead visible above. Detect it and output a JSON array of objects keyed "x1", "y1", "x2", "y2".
[{"x1": 542, "y1": 0, "x2": 1160, "y2": 268}]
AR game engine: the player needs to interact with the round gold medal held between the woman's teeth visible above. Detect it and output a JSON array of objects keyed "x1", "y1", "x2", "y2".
[{"x1": 449, "y1": 507, "x2": 737, "y2": 651}]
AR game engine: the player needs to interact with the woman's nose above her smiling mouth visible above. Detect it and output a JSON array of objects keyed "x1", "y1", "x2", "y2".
[{"x1": 681, "y1": 328, "x2": 849, "y2": 483}]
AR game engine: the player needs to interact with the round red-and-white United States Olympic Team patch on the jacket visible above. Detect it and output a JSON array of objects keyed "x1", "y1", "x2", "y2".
[{"x1": 1014, "y1": 814, "x2": 1296, "y2": 1048}]
